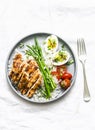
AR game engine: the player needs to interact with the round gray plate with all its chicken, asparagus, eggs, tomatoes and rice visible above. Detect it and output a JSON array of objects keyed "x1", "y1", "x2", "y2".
[{"x1": 6, "y1": 33, "x2": 77, "y2": 103}]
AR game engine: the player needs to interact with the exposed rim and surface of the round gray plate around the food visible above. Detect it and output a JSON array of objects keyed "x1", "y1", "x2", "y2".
[{"x1": 6, "y1": 33, "x2": 77, "y2": 103}]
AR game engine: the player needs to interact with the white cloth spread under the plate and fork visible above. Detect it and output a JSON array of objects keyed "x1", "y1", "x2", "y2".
[{"x1": 0, "y1": 0, "x2": 95, "y2": 130}]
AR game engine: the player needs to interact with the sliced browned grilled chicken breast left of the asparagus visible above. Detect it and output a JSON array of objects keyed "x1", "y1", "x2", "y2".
[{"x1": 9, "y1": 54, "x2": 42, "y2": 98}]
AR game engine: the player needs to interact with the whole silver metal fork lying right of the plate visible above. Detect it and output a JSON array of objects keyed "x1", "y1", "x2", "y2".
[{"x1": 77, "y1": 39, "x2": 91, "y2": 102}]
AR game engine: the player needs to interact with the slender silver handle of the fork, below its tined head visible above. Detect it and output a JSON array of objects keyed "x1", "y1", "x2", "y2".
[{"x1": 82, "y1": 63, "x2": 91, "y2": 102}]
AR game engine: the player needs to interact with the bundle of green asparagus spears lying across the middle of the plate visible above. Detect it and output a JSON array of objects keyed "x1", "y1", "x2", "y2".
[{"x1": 26, "y1": 38, "x2": 56, "y2": 98}]
